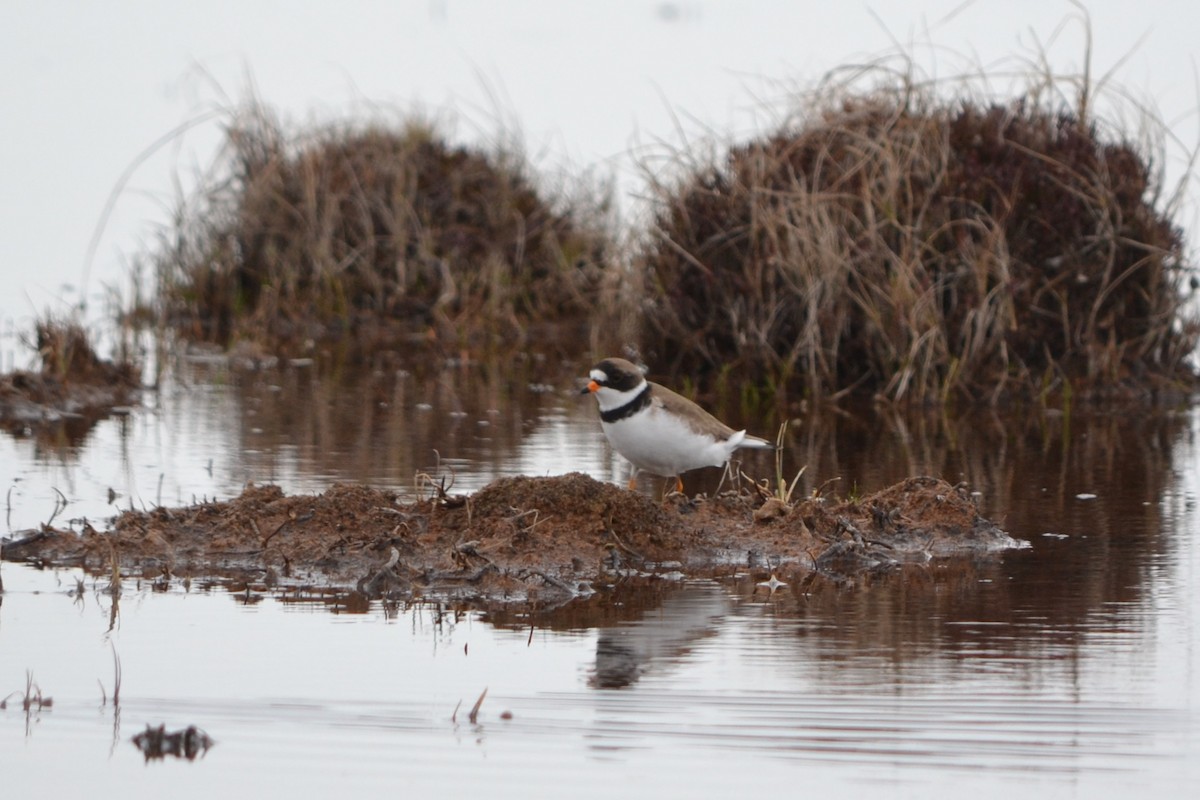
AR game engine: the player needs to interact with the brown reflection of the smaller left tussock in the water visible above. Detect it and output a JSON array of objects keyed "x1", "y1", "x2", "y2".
[{"x1": 223, "y1": 359, "x2": 559, "y2": 496}]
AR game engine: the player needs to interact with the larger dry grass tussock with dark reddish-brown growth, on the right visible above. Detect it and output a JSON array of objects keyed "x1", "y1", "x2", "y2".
[{"x1": 641, "y1": 59, "x2": 1200, "y2": 403}]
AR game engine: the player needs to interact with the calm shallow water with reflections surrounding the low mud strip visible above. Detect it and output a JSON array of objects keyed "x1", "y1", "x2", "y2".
[{"x1": 0, "y1": 362, "x2": 1200, "y2": 798}]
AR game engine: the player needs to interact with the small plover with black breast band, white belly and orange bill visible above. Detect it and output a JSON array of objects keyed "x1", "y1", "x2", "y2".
[{"x1": 581, "y1": 359, "x2": 775, "y2": 492}]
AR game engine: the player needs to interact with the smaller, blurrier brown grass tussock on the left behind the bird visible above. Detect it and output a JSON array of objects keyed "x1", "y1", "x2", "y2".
[{"x1": 156, "y1": 106, "x2": 611, "y2": 351}]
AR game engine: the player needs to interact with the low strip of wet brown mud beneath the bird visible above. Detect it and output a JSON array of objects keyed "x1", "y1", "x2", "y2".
[{"x1": 2, "y1": 473, "x2": 1021, "y2": 600}]
